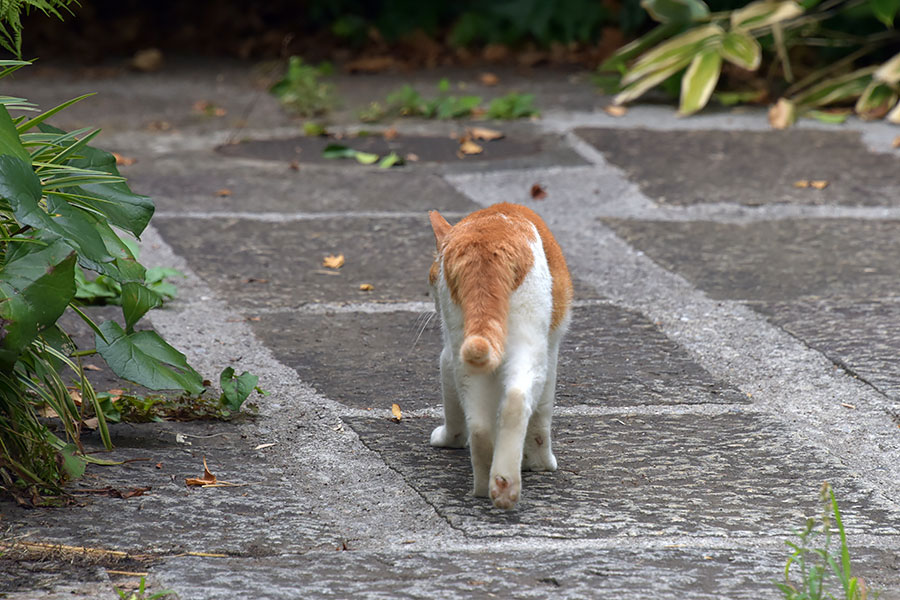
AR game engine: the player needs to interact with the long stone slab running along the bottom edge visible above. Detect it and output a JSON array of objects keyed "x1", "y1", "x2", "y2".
[{"x1": 153, "y1": 548, "x2": 900, "y2": 600}]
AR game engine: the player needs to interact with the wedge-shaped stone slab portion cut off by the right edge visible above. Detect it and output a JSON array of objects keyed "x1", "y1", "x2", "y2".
[{"x1": 753, "y1": 297, "x2": 900, "y2": 400}]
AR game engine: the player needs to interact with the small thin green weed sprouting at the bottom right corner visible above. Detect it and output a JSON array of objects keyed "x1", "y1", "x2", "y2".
[{"x1": 775, "y1": 482, "x2": 877, "y2": 600}]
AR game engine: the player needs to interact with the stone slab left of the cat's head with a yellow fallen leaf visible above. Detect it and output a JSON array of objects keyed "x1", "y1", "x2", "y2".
[{"x1": 156, "y1": 217, "x2": 434, "y2": 311}]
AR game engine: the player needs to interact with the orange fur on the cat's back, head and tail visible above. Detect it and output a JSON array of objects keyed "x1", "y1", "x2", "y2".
[{"x1": 429, "y1": 203, "x2": 572, "y2": 371}]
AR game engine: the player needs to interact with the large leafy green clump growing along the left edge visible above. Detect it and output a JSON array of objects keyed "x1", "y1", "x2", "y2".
[{"x1": 0, "y1": 61, "x2": 210, "y2": 498}]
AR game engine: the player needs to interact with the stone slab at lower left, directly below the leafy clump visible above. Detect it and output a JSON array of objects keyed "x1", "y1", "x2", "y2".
[{"x1": 0, "y1": 422, "x2": 327, "y2": 556}]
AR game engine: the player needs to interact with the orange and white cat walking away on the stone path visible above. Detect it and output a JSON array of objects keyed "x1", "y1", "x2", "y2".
[{"x1": 428, "y1": 203, "x2": 573, "y2": 509}]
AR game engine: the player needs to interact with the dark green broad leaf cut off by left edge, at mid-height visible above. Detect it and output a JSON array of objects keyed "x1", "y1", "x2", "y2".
[{"x1": 0, "y1": 242, "x2": 75, "y2": 369}]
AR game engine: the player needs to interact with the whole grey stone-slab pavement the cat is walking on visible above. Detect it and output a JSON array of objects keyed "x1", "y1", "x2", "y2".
[{"x1": 0, "y1": 63, "x2": 900, "y2": 600}]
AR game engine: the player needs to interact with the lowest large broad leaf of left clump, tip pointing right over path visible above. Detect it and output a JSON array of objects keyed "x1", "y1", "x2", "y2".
[{"x1": 95, "y1": 321, "x2": 203, "y2": 394}]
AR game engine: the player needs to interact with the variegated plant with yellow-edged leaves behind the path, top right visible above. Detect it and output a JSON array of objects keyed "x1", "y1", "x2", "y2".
[{"x1": 601, "y1": 0, "x2": 900, "y2": 127}]
